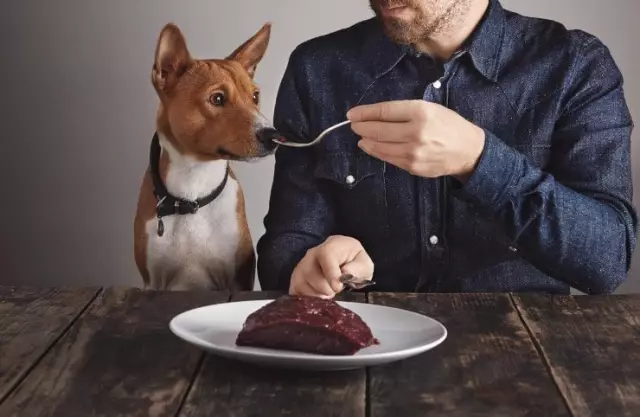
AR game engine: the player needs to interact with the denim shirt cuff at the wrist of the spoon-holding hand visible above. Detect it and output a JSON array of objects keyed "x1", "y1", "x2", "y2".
[{"x1": 459, "y1": 129, "x2": 524, "y2": 212}]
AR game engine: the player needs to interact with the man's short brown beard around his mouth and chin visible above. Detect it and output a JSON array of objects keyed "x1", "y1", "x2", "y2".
[{"x1": 369, "y1": 0, "x2": 468, "y2": 45}]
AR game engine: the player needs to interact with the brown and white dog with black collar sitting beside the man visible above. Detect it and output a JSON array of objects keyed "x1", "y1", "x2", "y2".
[{"x1": 134, "y1": 23, "x2": 279, "y2": 291}]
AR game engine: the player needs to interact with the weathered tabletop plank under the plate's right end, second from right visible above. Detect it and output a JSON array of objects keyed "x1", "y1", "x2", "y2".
[{"x1": 369, "y1": 293, "x2": 569, "y2": 417}]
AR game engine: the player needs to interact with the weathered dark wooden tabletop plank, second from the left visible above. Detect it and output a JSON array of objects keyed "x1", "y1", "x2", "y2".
[{"x1": 0, "y1": 289, "x2": 229, "y2": 417}]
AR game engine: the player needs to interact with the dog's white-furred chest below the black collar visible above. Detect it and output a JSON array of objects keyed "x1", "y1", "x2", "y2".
[{"x1": 147, "y1": 178, "x2": 240, "y2": 279}]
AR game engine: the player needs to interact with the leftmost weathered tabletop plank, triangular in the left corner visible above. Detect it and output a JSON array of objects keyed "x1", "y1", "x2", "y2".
[{"x1": 0, "y1": 286, "x2": 100, "y2": 402}]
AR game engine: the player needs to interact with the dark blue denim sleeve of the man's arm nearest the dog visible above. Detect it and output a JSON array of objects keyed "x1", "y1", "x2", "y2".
[{"x1": 257, "y1": 51, "x2": 334, "y2": 291}]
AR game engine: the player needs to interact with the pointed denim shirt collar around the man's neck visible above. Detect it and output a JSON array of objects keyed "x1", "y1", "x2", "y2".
[{"x1": 362, "y1": 0, "x2": 506, "y2": 82}]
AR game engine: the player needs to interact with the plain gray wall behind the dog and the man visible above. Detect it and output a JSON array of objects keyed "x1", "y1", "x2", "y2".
[{"x1": 0, "y1": 0, "x2": 640, "y2": 292}]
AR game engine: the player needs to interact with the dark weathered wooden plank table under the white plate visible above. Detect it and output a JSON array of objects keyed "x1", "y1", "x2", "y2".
[{"x1": 0, "y1": 287, "x2": 640, "y2": 417}]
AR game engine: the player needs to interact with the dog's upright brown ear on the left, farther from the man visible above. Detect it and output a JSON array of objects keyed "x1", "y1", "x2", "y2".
[{"x1": 151, "y1": 23, "x2": 192, "y2": 92}]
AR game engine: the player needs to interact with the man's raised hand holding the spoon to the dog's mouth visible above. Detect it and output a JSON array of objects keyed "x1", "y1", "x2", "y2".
[{"x1": 347, "y1": 100, "x2": 485, "y2": 182}]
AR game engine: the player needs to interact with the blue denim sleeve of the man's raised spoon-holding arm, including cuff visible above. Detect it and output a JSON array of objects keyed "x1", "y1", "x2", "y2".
[{"x1": 460, "y1": 38, "x2": 637, "y2": 294}]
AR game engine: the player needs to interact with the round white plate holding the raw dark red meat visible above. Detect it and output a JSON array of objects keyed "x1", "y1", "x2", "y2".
[{"x1": 169, "y1": 300, "x2": 447, "y2": 371}]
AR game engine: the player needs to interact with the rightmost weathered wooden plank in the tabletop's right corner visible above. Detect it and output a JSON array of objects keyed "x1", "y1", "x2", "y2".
[{"x1": 513, "y1": 295, "x2": 640, "y2": 417}]
